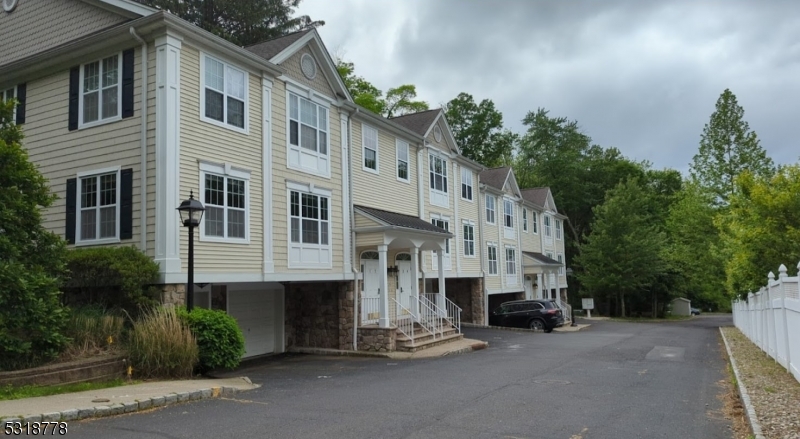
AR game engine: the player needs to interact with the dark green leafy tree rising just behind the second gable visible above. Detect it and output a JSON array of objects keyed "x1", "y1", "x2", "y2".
[{"x1": 444, "y1": 93, "x2": 518, "y2": 168}]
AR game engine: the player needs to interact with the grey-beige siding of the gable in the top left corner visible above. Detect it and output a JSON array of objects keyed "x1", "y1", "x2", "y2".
[{"x1": 0, "y1": 0, "x2": 128, "y2": 65}]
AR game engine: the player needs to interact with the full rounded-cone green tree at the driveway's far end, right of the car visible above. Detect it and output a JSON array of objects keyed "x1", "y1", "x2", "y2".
[{"x1": 576, "y1": 178, "x2": 668, "y2": 317}]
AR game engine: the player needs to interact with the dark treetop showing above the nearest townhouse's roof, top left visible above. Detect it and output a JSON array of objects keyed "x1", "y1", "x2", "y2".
[{"x1": 137, "y1": 0, "x2": 325, "y2": 46}]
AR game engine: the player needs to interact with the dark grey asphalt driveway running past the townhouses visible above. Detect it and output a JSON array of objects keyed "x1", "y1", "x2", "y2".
[{"x1": 70, "y1": 315, "x2": 731, "y2": 439}]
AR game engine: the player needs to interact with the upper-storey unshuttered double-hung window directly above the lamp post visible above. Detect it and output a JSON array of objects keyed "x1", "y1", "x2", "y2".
[{"x1": 202, "y1": 55, "x2": 247, "y2": 131}]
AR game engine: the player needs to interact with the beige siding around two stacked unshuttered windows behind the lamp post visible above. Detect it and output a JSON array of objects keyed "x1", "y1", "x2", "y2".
[{"x1": 180, "y1": 49, "x2": 264, "y2": 273}]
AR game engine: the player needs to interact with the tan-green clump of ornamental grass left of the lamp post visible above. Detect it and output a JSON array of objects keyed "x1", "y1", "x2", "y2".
[{"x1": 126, "y1": 306, "x2": 199, "y2": 378}]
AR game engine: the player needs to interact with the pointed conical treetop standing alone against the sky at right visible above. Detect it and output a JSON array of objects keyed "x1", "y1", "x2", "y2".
[{"x1": 689, "y1": 89, "x2": 775, "y2": 205}]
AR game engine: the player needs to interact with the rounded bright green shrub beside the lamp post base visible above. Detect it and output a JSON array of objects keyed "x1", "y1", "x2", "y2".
[{"x1": 178, "y1": 308, "x2": 244, "y2": 373}]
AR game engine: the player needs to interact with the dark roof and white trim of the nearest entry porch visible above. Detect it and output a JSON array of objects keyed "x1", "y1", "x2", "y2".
[{"x1": 353, "y1": 205, "x2": 453, "y2": 250}]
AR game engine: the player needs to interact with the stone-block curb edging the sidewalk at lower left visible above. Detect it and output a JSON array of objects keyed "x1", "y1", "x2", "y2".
[{"x1": 0, "y1": 387, "x2": 240, "y2": 425}]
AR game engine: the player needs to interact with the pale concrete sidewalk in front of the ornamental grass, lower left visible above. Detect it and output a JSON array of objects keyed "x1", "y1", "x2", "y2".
[{"x1": 0, "y1": 377, "x2": 259, "y2": 422}]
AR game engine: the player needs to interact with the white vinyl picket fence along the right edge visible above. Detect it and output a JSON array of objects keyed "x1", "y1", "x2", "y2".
[{"x1": 733, "y1": 264, "x2": 800, "y2": 381}]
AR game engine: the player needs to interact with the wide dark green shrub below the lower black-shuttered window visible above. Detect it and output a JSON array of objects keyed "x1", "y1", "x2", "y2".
[{"x1": 64, "y1": 247, "x2": 158, "y2": 317}]
